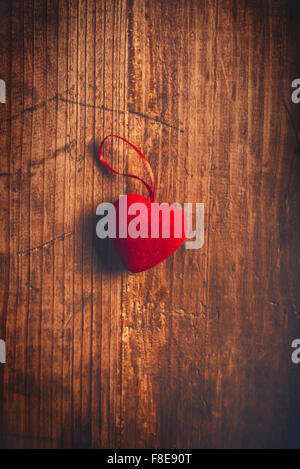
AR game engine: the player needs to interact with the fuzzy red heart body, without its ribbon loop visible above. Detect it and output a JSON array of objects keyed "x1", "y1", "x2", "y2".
[{"x1": 111, "y1": 194, "x2": 186, "y2": 273}]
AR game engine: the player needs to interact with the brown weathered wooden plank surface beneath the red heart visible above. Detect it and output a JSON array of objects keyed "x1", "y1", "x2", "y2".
[{"x1": 0, "y1": 0, "x2": 300, "y2": 448}]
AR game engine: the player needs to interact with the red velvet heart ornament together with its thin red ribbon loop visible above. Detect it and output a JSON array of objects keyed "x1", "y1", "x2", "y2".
[{"x1": 99, "y1": 135, "x2": 187, "y2": 273}]
